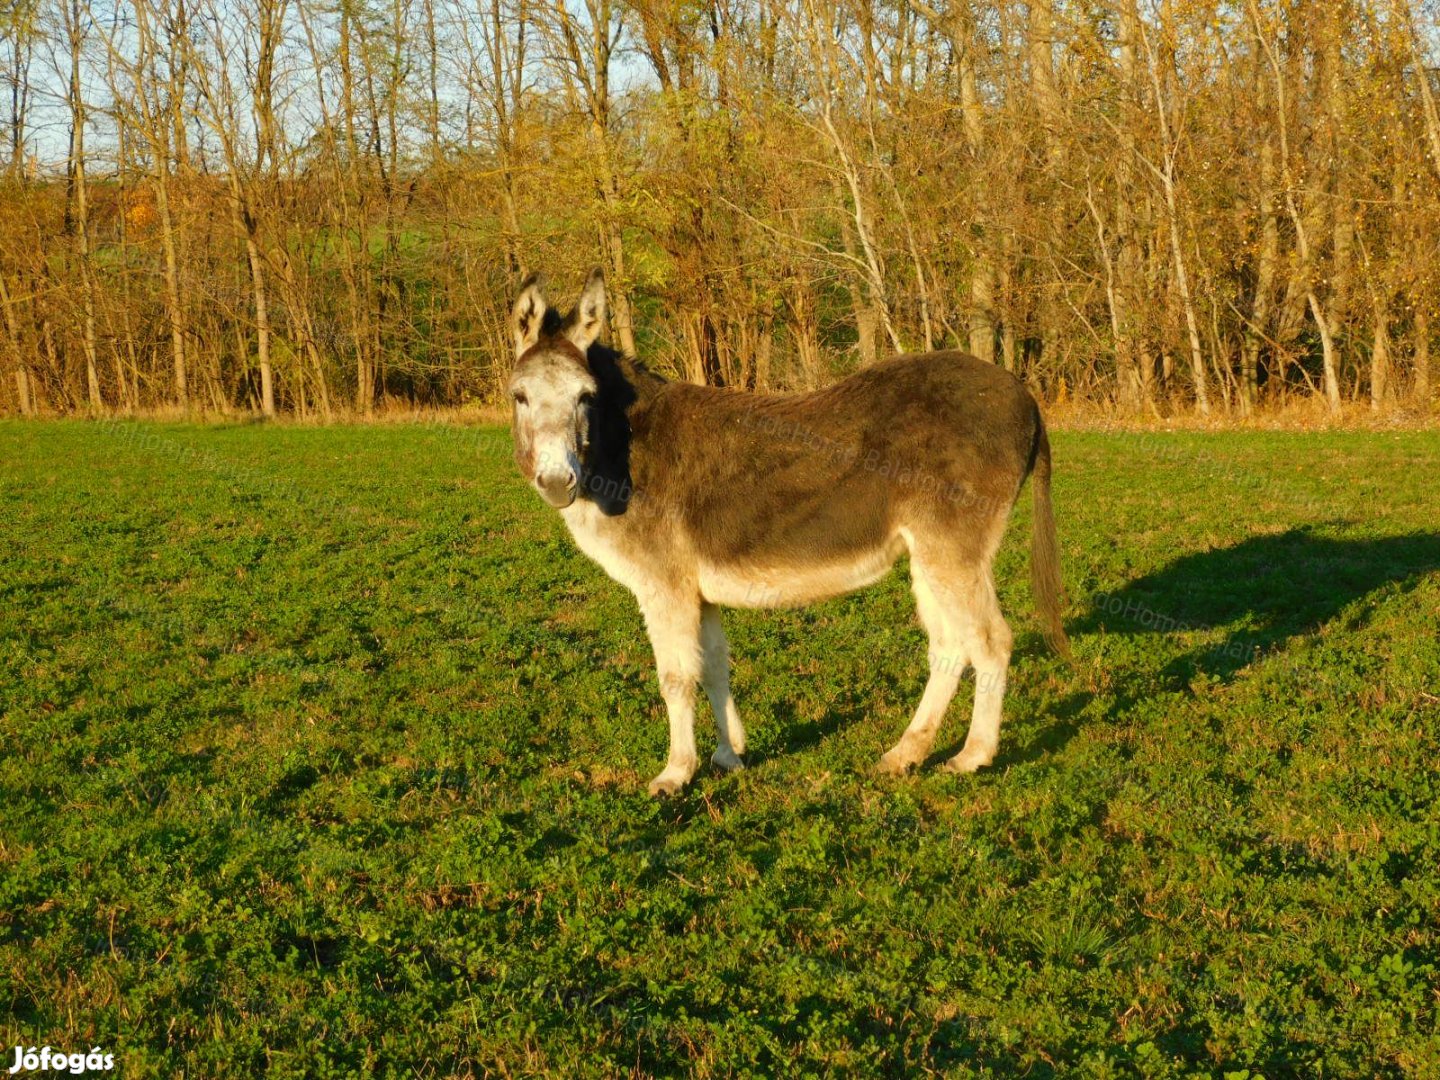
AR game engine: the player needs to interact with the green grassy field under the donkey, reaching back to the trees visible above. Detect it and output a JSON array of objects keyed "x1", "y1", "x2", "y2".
[{"x1": 0, "y1": 422, "x2": 1440, "y2": 1077}]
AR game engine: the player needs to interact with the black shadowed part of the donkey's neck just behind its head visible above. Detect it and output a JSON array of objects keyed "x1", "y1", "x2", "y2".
[{"x1": 582, "y1": 344, "x2": 667, "y2": 517}]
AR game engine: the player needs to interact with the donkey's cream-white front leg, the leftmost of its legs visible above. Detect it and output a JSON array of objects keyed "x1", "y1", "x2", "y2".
[{"x1": 641, "y1": 590, "x2": 701, "y2": 795}]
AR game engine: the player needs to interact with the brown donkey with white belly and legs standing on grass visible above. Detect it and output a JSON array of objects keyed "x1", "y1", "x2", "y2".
[{"x1": 510, "y1": 271, "x2": 1070, "y2": 795}]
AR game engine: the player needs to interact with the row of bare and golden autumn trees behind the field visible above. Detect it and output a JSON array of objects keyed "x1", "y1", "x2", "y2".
[{"x1": 0, "y1": 0, "x2": 1440, "y2": 415}]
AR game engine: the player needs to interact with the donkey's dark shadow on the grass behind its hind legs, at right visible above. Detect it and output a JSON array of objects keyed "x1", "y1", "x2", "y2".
[{"x1": 979, "y1": 526, "x2": 1440, "y2": 765}]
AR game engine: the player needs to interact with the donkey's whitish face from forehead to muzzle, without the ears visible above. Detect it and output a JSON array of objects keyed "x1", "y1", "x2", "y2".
[{"x1": 510, "y1": 348, "x2": 596, "y2": 508}]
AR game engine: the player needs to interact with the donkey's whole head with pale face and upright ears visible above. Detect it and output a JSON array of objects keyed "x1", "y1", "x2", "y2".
[{"x1": 510, "y1": 271, "x2": 605, "y2": 510}]
